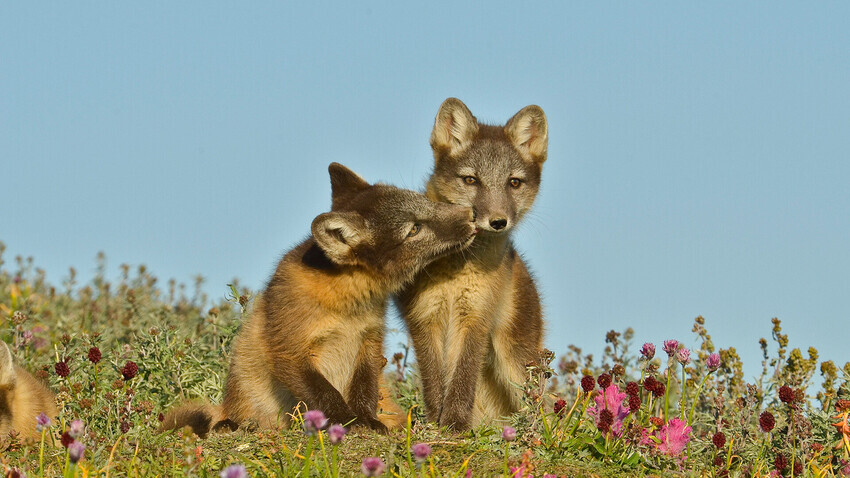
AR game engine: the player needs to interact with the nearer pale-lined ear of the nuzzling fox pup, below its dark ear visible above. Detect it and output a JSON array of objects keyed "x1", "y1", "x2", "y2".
[{"x1": 311, "y1": 212, "x2": 369, "y2": 265}]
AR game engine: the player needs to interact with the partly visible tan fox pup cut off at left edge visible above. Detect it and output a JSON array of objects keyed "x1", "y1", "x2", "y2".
[{"x1": 0, "y1": 342, "x2": 58, "y2": 440}]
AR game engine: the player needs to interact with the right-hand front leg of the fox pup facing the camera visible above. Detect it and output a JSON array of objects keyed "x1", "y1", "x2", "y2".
[{"x1": 440, "y1": 315, "x2": 488, "y2": 431}]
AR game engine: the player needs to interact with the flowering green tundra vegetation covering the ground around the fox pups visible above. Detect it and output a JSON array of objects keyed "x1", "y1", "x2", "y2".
[{"x1": 0, "y1": 243, "x2": 850, "y2": 477}]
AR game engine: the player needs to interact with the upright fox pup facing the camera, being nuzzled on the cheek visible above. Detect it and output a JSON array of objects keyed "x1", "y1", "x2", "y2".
[{"x1": 397, "y1": 98, "x2": 548, "y2": 430}]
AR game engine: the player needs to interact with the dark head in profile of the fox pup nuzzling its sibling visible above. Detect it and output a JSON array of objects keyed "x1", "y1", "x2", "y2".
[{"x1": 312, "y1": 163, "x2": 475, "y2": 287}]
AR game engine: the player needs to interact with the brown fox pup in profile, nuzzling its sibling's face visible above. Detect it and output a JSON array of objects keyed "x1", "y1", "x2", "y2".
[{"x1": 163, "y1": 163, "x2": 475, "y2": 436}]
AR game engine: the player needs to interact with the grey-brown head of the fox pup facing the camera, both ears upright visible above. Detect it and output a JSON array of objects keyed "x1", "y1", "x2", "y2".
[{"x1": 428, "y1": 98, "x2": 548, "y2": 234}]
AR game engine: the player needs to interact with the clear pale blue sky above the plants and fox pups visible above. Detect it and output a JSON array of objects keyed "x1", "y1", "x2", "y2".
[{"x1": 0, "y1": 1, "x2": 850, "y2": 374}]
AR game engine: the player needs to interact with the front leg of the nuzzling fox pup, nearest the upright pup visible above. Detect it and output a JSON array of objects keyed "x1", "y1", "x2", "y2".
[{"x1": 348, "y1": 330, "x2": 387, "y2": 433}]
